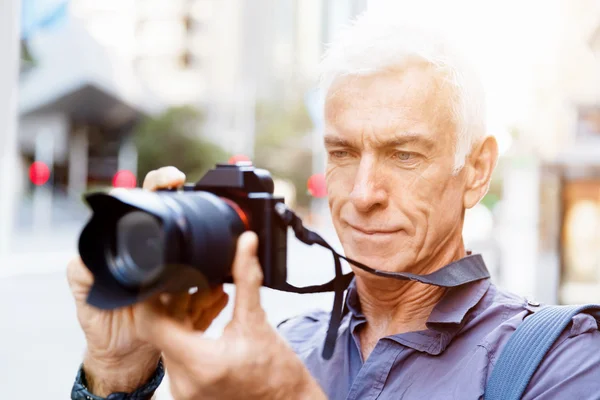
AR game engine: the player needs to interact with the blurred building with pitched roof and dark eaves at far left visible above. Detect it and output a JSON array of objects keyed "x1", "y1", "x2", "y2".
[{"x1": 19, "y1": 21, "x2": 152, "y2": 200}]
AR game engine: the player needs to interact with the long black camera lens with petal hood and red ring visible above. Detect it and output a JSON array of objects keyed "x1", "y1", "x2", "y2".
[{"x1": 79, "y1": 190, "x2": 248, "y2": 308}]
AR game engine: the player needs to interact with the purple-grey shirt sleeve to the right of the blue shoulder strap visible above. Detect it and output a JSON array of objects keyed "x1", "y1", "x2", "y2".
[{"x1": 523, "y1": 314, "x2": 600, "y2": 400}]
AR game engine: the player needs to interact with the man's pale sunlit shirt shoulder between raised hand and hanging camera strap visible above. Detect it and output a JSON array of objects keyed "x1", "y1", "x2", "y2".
[{"x1": 277, "y1": 310, "x2": 331, "y2": 354}]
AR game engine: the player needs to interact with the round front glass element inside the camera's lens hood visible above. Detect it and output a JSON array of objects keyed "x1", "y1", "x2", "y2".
[{"x1": 109, "y1": 211, "x2": 165, "y2": 286}]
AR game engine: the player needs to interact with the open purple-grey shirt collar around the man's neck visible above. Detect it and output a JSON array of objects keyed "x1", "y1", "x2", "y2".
[{"x1": 346, "y1": 256, "x2": 491, "y2": 355}]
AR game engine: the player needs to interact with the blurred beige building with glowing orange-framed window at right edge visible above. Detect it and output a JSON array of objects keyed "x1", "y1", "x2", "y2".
[{"x1": 536, "y1": 0, "x2": 600, "y2": 303}]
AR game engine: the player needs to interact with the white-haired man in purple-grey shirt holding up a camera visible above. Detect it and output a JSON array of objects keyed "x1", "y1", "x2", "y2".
[{"x1": 69, "y1": 11, "x2": 600, "y2": 399}]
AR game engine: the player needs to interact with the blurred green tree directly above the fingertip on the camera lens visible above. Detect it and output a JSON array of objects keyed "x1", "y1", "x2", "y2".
[{"x1": 134, "y1": 106, "x2": 229, "y2": 182}]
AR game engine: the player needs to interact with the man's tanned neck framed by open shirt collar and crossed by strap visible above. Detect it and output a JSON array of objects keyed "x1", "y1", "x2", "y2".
[{"x1": 356, "y1": 242, "x2": 466, "y2": 359}]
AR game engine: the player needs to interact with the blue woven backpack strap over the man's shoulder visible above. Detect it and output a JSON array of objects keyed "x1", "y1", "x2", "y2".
[{"x1": 484, "y1": 304, "x2": 600, "y2": 400}]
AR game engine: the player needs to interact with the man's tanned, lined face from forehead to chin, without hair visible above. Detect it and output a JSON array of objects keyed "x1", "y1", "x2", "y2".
[{"x1": 325, "y1": 62, "x2": 465, "y2": 273}]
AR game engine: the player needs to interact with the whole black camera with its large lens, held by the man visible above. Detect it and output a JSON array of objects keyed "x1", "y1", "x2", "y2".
[{"x1": 79, "y1": 163, "x2": 287, "y2": 309}]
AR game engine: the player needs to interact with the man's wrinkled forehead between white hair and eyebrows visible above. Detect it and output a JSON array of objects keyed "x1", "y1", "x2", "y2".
[{"x1": 325, "y1": 61, "x2": 457, "y2": 147}]
